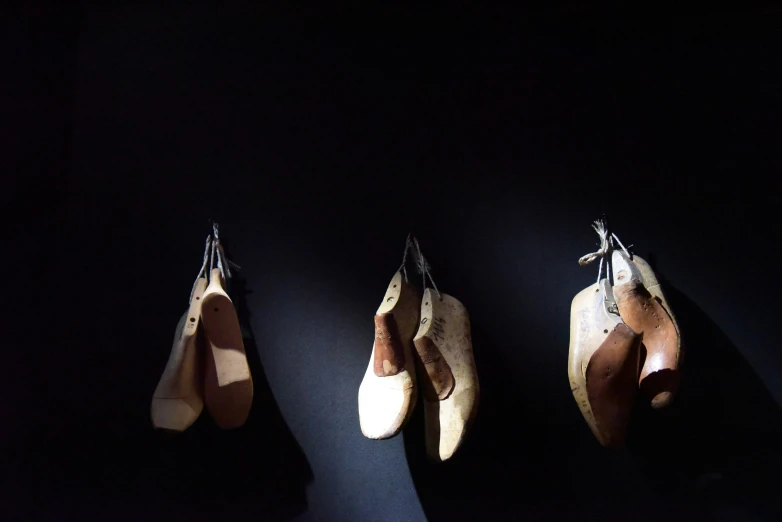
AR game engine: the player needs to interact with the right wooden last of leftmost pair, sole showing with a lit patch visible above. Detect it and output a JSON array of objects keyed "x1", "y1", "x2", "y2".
[{"x1": 201, "y1": 269, "x2": 253, "y2": 429}]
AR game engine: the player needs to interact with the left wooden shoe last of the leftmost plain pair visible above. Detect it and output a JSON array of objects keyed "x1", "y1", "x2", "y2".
[{"x1": 150, "y1": 278, "x2": 206, "y2": 431}]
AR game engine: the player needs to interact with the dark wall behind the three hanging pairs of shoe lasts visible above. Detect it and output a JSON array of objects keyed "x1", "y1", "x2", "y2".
[{"x1": 4, "y1": 8, "x2": 782, "y2": 521}]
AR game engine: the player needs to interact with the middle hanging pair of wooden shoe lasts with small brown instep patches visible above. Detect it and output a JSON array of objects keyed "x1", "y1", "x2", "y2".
[{"x1": 358, "y1": 272, "x2": 479, "y2": 461}]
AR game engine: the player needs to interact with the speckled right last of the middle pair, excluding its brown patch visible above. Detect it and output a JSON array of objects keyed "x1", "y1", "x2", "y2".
[{"x1": 415, "y1": 288, "x2": 480, "y2": 462}]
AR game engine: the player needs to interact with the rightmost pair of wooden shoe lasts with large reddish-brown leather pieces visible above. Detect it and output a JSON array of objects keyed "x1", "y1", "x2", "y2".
[{"x1": 568, "y1": 243, "x2": 682, "y2": 447}]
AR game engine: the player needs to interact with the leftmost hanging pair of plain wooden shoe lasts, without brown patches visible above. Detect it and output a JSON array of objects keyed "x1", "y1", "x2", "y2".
[{"x1": 152, "y1": 268, "x2": 253, "y2": 431}]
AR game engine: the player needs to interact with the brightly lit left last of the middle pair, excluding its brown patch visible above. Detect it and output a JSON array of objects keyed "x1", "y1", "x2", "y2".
[{"x1": 358, "y1": 272, "x2": 421, "y2": 439}]
